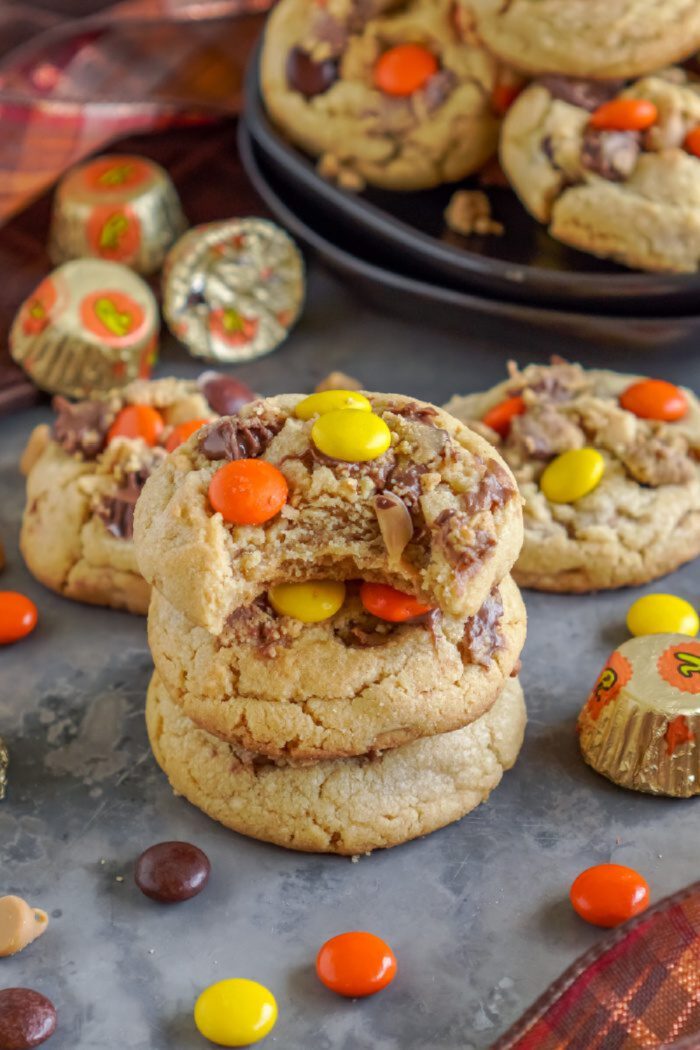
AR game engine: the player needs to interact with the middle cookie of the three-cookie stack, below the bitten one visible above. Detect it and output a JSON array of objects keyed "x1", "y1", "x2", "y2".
[{"x1": 148, "y1": 578, "x2": 526, "y2": 764}]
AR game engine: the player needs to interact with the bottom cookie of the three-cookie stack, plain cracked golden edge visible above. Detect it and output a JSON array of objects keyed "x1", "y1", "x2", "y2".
[{"x1": 146, "y1": 674, "x2": 526, "y2": 855}]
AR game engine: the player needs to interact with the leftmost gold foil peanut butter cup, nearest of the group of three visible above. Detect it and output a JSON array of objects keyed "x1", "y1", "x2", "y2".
[{"x1": 9, "y1": 259, "x2": 160, "y2": 398}]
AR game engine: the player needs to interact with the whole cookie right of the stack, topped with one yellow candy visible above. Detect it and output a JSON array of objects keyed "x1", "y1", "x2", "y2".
[{"x1": 447, "y1": 362, "x2": 700, "y2": 592}]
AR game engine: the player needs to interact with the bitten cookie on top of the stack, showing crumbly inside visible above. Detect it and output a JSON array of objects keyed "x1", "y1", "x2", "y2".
[{"x1": 134, "y1": 393, "x2": 523, "y2": 634}]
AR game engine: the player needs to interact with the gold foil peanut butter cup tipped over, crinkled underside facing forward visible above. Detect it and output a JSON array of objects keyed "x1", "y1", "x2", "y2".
[{"x1": 163, "y1": 218, "x2": 304, "y2": 363}]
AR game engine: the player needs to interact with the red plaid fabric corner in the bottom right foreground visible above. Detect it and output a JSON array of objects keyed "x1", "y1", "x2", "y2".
[{"x1": 492, "y1": 882, "x2": 700, "y2": 1050}]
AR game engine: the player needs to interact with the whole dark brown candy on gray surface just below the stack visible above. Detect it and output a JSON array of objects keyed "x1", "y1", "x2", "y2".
[{"x1": 134, "y1": 842, "x2": 211, "y2": 902}]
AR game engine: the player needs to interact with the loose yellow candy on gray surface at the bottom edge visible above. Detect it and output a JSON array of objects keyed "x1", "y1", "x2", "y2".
[{"x1": 194, "y1": 978, "x2": 277, "y2": 1047}]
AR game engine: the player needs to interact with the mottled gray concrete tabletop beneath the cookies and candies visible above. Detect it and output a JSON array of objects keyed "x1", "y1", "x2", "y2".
[{"x1": 0, "y1": 264, "x2": 700, "y2": 1050}]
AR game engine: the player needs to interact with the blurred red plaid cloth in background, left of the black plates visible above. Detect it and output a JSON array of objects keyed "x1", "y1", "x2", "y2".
[{"x1": 0, "y1": 0, "x2": 271, "y2": 224}]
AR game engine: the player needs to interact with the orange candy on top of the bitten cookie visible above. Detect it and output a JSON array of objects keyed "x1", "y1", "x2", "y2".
[{"x1": 209, "y1": 460, "x2": 289, "y2": 525}]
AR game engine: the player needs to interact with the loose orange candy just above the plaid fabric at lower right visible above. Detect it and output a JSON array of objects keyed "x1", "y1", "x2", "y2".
[{"x1": 569, "y1": 864, "x2": 650, "y2": 928}]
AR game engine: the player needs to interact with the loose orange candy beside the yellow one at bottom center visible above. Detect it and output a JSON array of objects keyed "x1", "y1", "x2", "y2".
[{"x1": 316, "y1": 931, "x2": 397, "y2": 999}]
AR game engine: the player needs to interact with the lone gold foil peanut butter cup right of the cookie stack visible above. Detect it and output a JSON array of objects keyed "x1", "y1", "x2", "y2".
[{"x1": 578, "y1": 634, "x2": 700, "y2": 798}]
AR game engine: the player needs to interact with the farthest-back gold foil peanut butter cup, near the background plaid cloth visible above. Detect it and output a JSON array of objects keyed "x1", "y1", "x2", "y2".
[{"x1": 48, "y1": 154, "x2": 187, "y2": 274}]
